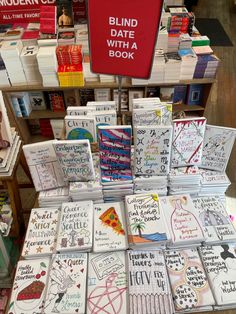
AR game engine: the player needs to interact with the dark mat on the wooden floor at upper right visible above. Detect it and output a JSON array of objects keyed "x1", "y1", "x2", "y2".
[{"x1": 195, "y1": 18, "x2": 233, "y2": 47}]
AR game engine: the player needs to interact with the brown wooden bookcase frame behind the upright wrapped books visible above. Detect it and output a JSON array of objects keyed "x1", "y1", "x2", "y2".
[{"x1": 2, "y1": 79, "x2": 216, "y2": 143}]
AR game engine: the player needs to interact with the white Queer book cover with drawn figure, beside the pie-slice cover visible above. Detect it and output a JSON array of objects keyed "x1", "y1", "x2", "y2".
[{"x1": 43, "y1": 253, "x2": 88, "y2": 314}]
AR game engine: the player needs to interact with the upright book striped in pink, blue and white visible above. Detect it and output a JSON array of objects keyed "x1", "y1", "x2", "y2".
[{"x1": 98, "y1": 125, "x2": 132, "y2": 170}]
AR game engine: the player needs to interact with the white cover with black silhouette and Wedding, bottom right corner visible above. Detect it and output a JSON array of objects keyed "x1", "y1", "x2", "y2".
[{"x1": 199, "y1": 244, "x2": 236, "y2": 306}]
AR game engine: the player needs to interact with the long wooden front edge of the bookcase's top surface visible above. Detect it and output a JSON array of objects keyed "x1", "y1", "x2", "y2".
[{"x1": 1, "y1": 79, "x2": 216, "y2": 92}]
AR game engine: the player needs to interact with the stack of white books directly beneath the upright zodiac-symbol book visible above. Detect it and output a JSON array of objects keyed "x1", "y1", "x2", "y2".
[{"x1": 134, "y1": 175, "x2": 167, "y2": 196}]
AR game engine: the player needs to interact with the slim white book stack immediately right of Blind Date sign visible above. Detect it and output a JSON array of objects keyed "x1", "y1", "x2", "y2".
[{"x1": 148, "y1": 49, "x2": 165, "y2": 84}]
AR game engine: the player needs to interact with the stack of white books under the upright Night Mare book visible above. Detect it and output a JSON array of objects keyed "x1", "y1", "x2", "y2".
[{"x1": 168, "y1": 166, "x2": 201, "y2": 196}]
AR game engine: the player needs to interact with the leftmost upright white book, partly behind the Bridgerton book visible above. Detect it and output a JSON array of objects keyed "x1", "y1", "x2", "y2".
[{"x1": 23, "y1": 141, "x2": 65, "y2": 191}]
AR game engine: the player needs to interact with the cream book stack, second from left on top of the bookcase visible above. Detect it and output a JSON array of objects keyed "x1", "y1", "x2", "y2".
[{"x1": 20, "y1": 46, "x2": 42, "y2": 85}]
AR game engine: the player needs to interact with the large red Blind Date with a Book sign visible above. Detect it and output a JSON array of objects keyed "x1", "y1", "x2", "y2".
[{"x1": 88, "y1": 0, "x2": 163, "y2": 78}]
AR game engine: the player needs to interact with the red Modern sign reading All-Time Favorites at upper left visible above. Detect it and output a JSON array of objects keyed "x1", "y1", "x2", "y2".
[{"x1": 0, "y1": 0, "x2": 56, "y2": 24}]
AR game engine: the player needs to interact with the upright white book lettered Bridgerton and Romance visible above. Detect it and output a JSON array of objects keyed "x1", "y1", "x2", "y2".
[{"x1": 53, "y1": 140, "x2": 95, "y2": 181}]
